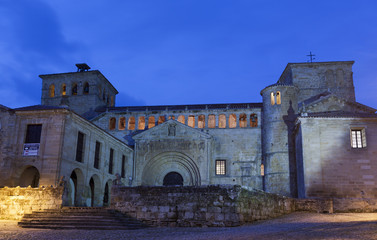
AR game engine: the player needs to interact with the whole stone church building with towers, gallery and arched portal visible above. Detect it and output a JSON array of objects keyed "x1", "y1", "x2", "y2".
[{"x1": 0, "y1": 61, "x2": 377, "y2": 209}]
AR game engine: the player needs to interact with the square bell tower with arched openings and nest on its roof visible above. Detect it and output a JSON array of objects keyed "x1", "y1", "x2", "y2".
[{"x1": 39, "y1": 63, "x2": 118, "y2": 118}]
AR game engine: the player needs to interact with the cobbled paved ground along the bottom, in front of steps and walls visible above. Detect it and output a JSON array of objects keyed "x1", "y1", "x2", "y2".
[{"x1": 0, "y1": 213, "x2": 377, "y2": 240}]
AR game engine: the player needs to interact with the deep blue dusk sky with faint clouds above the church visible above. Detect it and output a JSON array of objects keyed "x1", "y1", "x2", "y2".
[{"x1": 0, "y1": 0, "x2": 377, "y2": 108}]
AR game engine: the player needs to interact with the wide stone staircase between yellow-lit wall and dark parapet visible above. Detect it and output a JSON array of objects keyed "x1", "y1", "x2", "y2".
[{"x1": 18, "y1": 207, "x2": 147, "y2": 230}]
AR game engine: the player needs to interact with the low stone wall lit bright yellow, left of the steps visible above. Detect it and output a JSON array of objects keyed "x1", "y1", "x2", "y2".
[{"x1": 0, "y1": 186, "x2": 64, "y2": 220}]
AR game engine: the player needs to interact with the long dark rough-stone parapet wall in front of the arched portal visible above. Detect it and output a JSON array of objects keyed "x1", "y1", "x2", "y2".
[{"x1": 111, "y1": 185, "x2": 328, "y2": 227}]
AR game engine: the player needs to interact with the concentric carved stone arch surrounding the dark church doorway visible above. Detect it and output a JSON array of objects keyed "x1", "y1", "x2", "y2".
[{"x1": 141, "y1": 152, "x2": 201, "y2": 186}]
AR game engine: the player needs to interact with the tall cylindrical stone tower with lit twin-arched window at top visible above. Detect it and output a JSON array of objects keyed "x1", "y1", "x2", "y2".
[{"x1": 261, "y1": 83, "x2": 298, "y2": 196}]
